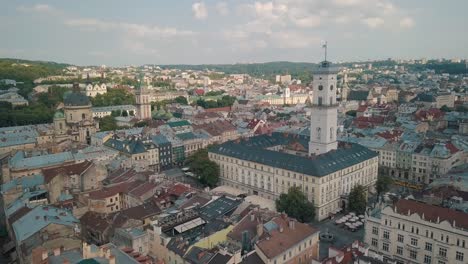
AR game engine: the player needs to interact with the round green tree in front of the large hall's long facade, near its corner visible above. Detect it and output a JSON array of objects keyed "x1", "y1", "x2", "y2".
[{"x1": 275, "y1": 187, "x2": 315, "y2": 222}]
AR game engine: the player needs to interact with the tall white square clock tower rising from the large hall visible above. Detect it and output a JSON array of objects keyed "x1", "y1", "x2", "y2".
[{"x1": 309, "y1": 57, "x2": 339, "y2": 155}]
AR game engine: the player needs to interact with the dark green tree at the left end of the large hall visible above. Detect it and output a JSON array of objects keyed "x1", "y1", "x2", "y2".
[{"x1": 187, "y1": 148, "x2": 219, "y2": 188}]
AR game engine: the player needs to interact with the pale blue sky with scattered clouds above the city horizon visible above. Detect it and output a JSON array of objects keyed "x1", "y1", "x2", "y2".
[{"x1": 0, "y1": 0, "x2": 468, "y2": 66}]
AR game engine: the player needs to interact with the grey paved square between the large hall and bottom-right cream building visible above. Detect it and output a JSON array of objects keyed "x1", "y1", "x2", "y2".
[{"x1": 312, "y1": 214, "x2": 364, "y2": 260}]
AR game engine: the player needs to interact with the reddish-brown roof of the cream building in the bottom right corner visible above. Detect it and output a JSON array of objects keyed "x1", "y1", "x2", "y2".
[{"x1": 395, "y1": 199, "x2": 468, "y2": 229}]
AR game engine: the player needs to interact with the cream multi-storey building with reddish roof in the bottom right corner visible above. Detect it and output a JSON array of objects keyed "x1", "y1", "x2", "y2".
[{"x1": 365, "y1": 199, "x2": 468, "y2": 264}]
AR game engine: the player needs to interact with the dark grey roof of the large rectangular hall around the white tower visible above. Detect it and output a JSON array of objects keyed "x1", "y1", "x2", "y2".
[{"x1": 209, "y1": 133, "x2": 378, "y2": 177}]
